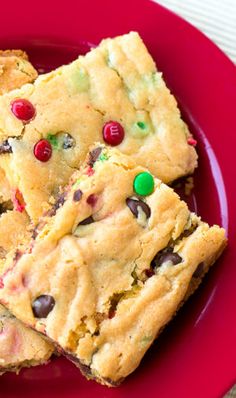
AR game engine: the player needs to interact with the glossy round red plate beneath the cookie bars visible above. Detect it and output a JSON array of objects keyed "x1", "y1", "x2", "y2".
[{"x1": 0, "y1": 0, "x2": 236, "y2": 398}]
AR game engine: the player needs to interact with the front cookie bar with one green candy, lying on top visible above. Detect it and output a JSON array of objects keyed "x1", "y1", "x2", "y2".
[{"x1": 0, "y1": 144, "x2": 226, "y2": 385}]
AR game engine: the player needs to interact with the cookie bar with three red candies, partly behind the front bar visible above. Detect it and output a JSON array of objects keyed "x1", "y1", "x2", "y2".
[{"x1": 0, "y1": 32, "x2": 197, "y2": 222}]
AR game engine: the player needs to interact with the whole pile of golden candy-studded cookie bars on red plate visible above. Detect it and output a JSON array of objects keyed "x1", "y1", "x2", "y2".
[{"x1": 0, "y1": 32, "x2": 226, "y2": 386}]
